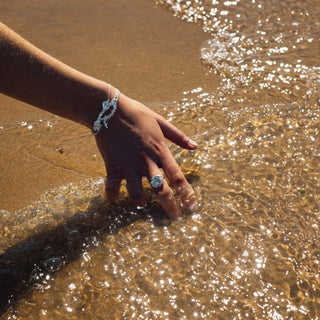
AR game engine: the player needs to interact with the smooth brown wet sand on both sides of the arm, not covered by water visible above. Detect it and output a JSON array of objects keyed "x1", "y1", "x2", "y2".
[{"x1": 0, "y1": 0, "x2": 214, "y2": 211}]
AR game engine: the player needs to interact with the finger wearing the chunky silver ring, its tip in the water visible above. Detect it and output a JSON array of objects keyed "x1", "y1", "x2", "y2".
[{"x1": 148, "y1": 160, "x2": 182, "y2": 219}]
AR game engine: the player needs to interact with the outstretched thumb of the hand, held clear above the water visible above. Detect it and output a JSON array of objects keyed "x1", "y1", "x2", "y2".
[{"x1": 157, "y1": 117, "x2": 198, "y2": 150}]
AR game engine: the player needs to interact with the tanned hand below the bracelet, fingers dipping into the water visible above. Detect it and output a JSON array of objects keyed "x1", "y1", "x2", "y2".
[{"x1": 96, "y1": 94, "x2": 197, "y2": 219}]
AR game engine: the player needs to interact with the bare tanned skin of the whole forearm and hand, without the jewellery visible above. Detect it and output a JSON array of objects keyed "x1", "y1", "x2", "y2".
[{"x1": 0, "y1": 23, "x2": 197, "y2": 219}]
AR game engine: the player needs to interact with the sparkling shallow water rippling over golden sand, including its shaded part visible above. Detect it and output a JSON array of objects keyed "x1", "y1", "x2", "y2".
[{"x1": 0, "y1": 0, "x2": 320, "y2": 319}]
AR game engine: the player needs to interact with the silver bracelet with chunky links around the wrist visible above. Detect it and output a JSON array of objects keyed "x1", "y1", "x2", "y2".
[{"x1": 92, "y1": 85, "x2": 120, "y2": 135}]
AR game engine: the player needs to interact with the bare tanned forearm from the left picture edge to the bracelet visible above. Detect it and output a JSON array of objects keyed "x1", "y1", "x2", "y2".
[{"x1": 0, "y1": 23, "x2": 108, "y2": 127}]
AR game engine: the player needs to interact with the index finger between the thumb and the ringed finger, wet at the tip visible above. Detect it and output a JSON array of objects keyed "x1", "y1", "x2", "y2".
[{"x1": 162, "y1": 150, "x2": 198, "y2": 212}]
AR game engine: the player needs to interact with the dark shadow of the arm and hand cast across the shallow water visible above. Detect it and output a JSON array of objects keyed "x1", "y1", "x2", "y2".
[{"x1": 0, "y1": 198, "x2": 170, "y2": 316}]
